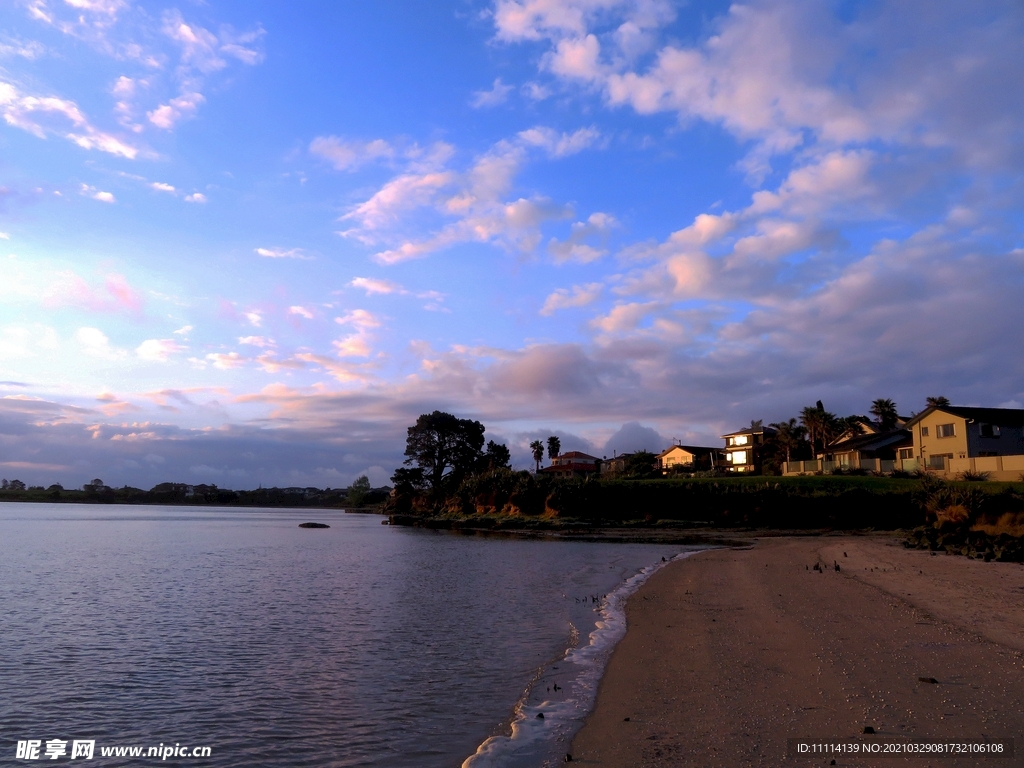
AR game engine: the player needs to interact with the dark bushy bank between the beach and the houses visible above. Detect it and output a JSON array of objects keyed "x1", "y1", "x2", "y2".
[{"x1": 390, "y1": 471, "x2": 1024, "y2": 530}]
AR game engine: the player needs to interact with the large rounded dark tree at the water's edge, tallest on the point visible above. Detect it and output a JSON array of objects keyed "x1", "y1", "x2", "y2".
[{"x1": 404, "y1": 411, "x2": 483, "y2": 492}]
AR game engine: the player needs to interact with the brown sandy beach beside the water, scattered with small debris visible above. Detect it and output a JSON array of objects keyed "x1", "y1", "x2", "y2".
[{"x1": 571, "y1": 536, "x2": 1024, "y2": 768}]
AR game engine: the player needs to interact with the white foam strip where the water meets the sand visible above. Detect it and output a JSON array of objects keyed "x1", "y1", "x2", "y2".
[{"x1": 462, "y1": 550, "x2": 697, "y2": 768}]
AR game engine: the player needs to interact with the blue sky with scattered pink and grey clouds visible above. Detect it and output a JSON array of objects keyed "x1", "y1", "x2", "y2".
[{"x1": 0, "y1": 0, "x2": 1024, "y2": 488}]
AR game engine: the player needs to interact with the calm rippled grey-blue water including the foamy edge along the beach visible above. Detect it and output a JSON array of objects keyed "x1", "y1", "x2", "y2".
[{"x1": 0, "y1": 503, "x2": 696, "y2": 768}]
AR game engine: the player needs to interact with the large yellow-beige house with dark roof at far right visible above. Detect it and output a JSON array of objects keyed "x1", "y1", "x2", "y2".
[{"x1": 900, "y1": 406, "x2": 1024, "y2": 480}]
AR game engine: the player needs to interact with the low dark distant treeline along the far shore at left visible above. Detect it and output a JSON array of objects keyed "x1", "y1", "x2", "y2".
[{"x1": 0, "y1": 478, "x2": 391, "y2": 507}]
